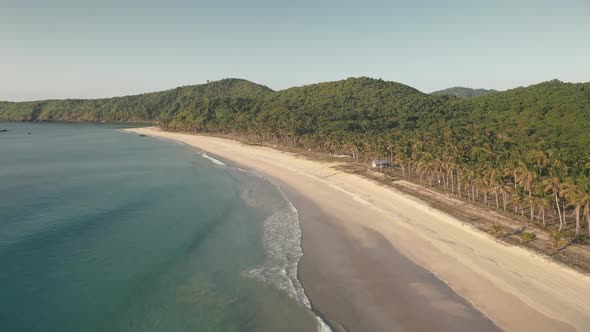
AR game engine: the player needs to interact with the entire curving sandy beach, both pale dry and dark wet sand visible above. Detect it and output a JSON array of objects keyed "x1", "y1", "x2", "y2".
[{"x1": 128, "y1": 128, "x2": 590, "y2": 331}]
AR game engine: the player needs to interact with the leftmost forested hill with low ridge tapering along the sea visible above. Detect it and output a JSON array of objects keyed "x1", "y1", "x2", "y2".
[{"x1": 0, "y1": 79, "x2": 273, "y2": 122}]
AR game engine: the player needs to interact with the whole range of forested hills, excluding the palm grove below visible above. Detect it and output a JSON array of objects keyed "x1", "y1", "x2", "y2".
[{"x1": 0, "y1": 77, "x2": 590, "y2": 160}]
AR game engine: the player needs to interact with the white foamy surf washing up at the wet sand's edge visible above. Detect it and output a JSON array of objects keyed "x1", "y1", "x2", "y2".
[{"x1": 247, "y1": 188, "x2": 332, "y2": 332}]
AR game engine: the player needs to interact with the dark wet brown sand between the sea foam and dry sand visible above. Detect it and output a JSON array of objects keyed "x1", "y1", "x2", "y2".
[{"x1": 284, "y1": 189, "x2": 500, "y2": 332}]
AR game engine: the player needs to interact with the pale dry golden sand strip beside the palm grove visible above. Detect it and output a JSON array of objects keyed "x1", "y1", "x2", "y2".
[{"x1": 129, "y1": 128, "x2": 590, "y2": 331}]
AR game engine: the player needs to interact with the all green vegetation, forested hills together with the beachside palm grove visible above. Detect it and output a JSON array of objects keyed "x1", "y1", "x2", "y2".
[{"x1": 0, "y1": 78, "x2": 590, "y2": 235}]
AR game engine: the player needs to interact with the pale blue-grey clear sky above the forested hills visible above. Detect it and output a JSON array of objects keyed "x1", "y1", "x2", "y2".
[{"x1": 0, "y1": 0, "x2": 590, "y2": 101}]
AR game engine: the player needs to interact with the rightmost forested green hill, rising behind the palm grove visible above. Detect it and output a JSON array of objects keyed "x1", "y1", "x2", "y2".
[{"x1": 449, "y1": 80, "x2": 590, "y2": 154}]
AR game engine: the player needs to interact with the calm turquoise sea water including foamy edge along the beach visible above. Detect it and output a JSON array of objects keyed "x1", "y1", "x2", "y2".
[{"x1": 0, "y1": 123, "x2": 324, "y2": 332}]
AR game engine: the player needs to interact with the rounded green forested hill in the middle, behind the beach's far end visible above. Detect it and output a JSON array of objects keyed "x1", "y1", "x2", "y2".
[{"x1": 160, "y1": 78, "x2": 447, "y2": 142}]
